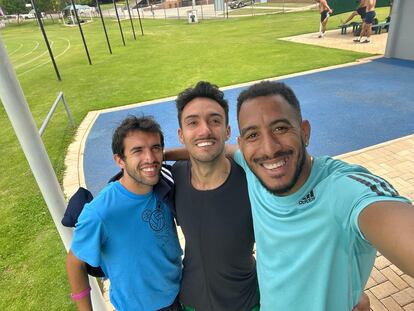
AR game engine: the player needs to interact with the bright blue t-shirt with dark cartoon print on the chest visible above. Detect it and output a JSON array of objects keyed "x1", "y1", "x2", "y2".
[{"x1": 71, "y1": 181, "x2": 182, "y2": 311}]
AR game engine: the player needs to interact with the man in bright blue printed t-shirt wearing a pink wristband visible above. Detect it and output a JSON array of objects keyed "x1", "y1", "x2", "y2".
[{"x1": 66, "y1": 116, "x2": 182, "y2": 311}]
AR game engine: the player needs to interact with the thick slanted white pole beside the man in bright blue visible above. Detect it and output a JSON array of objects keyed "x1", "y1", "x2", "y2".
[{"x1": 0, "y1": 37, "x2": 107, "y2": 311}]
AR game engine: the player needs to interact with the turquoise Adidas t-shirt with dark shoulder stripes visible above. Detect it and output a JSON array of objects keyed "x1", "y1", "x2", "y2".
[{"x1": 235, "y1": 151, "x2": 408, "y2": 311}]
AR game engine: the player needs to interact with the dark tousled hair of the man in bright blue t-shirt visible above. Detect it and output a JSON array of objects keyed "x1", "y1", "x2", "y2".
[{"x1": 112, "y1": 116, "x2": 164, "y2": 159}]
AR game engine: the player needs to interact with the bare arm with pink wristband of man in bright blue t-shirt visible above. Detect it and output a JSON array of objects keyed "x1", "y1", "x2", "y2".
[{"x1": 66, "y1": 251, "x2": 92, "y2": 311}]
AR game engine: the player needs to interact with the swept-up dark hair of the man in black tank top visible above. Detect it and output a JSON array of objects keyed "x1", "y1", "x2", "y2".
[{"x1": 175, "y1": 81, "x2": 229, "y2": 127}]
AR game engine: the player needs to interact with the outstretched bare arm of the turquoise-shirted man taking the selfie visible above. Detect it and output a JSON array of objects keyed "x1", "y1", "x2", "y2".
[{"x1": 359, "y1": 201, "x2": 414, "y2": 277}]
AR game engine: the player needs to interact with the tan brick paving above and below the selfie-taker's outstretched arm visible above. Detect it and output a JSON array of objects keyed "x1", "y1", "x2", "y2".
[{"x1": 338, "y1": 135, "x2": 414, "y2": 311}]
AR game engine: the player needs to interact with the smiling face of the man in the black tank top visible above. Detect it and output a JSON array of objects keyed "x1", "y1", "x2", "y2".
[{"x1": 178, "y1": 97, "x2": 230, "y2": 163}]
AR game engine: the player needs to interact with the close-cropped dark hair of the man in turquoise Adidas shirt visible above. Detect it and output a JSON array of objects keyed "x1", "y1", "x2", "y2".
[{"x1": 237, "y1": 81, "x2": 302, "y2": 121}]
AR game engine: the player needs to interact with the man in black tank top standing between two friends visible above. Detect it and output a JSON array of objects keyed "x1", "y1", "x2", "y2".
[{"x1": 173, "y1": 82, "x2": 259, "y2": 311}]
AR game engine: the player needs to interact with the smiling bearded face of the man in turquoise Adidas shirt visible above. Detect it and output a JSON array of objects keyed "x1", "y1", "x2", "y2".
[{"x1": 238, "y1": 95, "x2": 310, "y2": 196}]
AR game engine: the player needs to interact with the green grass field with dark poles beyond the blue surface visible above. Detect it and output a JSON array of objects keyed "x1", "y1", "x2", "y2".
[{"x1": 0, "y1": 7, "x2": 388, "y2": 311}]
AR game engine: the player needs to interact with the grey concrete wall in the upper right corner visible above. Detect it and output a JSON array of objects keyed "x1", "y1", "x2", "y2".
[{"x1": 385, "y1": 0, "x2": 414, "y2": 60}]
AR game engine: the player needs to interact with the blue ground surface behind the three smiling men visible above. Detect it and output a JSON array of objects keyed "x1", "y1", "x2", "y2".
[{"x1": 83, "y1": 58, "x2": 414, "y2": 195}]
